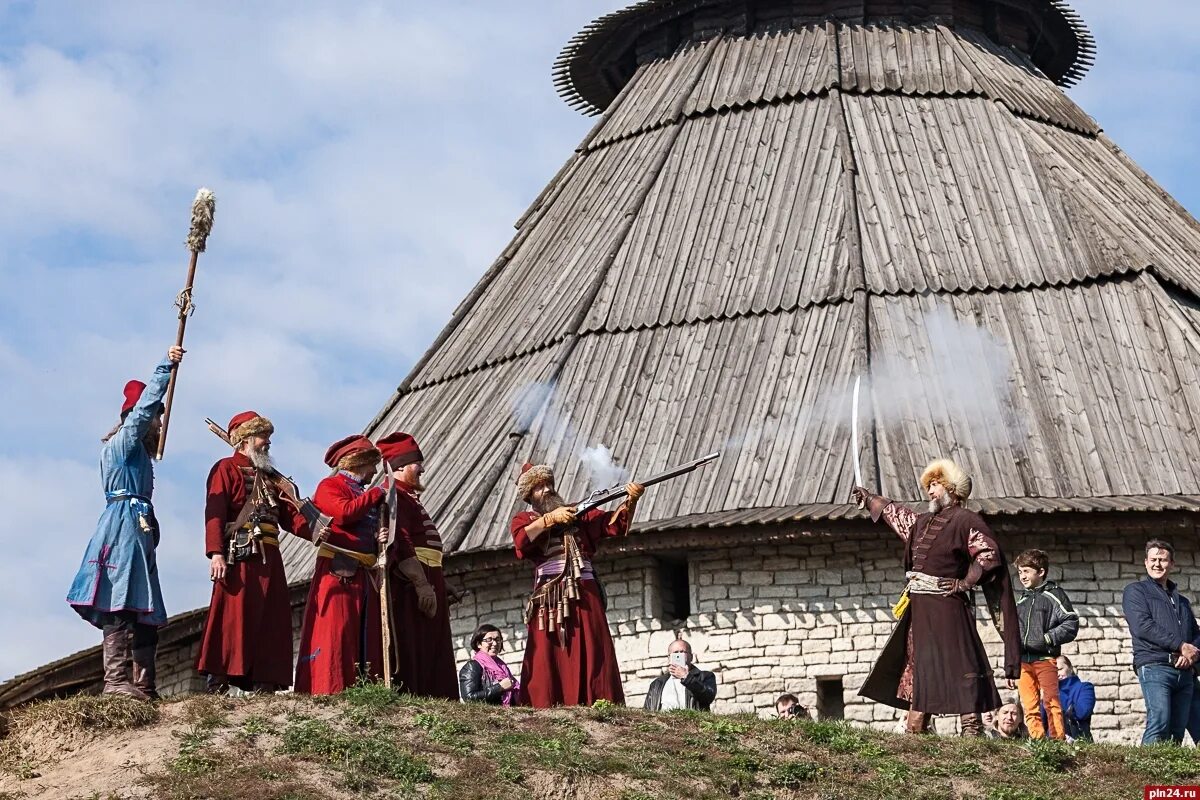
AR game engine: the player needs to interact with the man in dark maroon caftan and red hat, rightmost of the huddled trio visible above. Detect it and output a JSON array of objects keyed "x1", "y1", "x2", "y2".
[{"x1": 378, "y1": 433, "x2": 458, "y2": 700}]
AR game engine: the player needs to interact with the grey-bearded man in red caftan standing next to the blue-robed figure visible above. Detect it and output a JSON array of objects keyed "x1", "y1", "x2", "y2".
[{"x1": 196, "y1": 411, "x2": 311, "y2": 692}]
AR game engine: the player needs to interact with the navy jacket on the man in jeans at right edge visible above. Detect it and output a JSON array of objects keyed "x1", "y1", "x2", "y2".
[{"x1": 1121, "y1": 576, "x2": 1200, "y2": 669}]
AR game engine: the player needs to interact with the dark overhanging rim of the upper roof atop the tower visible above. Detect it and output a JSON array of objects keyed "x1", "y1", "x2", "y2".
[{"x1": 554, "y1": 0, "x2": 1096, "y2": 114}]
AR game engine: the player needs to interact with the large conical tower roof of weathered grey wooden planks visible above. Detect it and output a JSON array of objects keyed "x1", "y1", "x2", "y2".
[{"x1": 289, "y1": 2, "x2": 1200, "y2": 577}]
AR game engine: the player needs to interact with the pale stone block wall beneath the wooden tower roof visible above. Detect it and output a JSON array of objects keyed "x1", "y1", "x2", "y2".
[{"x1": 452, "y1": 524, "x2": 1200, "y2": 742}]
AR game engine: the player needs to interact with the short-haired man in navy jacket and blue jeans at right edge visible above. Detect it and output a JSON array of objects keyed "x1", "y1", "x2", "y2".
[{"x1": 1122, "y1": 539, "x2": 1200, "y2": 745}]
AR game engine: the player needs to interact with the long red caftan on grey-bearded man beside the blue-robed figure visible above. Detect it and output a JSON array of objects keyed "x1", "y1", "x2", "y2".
[{"x1": 196, "y1": 452, "x2": 311, "y2": 690}]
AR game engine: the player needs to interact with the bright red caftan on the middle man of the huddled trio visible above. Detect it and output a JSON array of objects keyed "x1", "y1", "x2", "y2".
[{"x1": 295, "y1": 471, "x2": 384, "y2": 694}]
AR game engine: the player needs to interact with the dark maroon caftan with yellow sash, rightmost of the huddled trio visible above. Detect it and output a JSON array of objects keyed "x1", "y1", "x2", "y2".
[{"x1": 388, "y1": 483, "x2": 458, "y2": 700}]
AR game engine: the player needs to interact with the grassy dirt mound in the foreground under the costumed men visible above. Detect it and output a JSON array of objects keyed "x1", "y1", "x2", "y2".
[{"x1": 0, "y1": 685, "x2": 1200, "y2": 800}]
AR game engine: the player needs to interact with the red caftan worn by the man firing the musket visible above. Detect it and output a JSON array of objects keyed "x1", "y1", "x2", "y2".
[{"x1": 511, "y1": 506, "x2": 629, "y2": 708}]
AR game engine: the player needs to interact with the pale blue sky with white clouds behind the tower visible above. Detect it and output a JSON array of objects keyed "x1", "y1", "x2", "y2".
[{"x1": 0, "y1": 0, "x2": 1200, "y2": 680}]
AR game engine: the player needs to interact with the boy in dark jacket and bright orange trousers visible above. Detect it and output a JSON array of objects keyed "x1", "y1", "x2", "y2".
[{"x1": 1008, "y1": 549, "x2": 1079, "y2": 739}]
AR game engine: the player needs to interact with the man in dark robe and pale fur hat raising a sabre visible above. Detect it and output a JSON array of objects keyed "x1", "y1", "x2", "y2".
[{"x1": 854, "y1": 459, "x2": 1021, "y2": 735}]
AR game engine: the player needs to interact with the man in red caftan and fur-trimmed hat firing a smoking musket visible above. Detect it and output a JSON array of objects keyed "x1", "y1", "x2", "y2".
[{"x1": 511, "y1": 464, "x2": 642, "y2": 708}]
